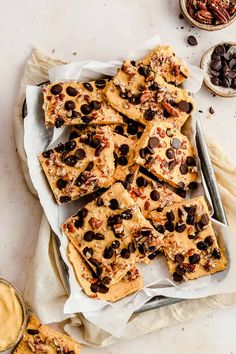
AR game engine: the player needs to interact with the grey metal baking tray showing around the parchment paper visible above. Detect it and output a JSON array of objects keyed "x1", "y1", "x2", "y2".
[{"x1": 22, "y1": 88, "x2": 228, "y2": 313}]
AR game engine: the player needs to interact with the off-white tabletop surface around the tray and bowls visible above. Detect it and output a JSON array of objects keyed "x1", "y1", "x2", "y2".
[{"x1": 0, "y1": 0, "x2": 236, "y2": 354}]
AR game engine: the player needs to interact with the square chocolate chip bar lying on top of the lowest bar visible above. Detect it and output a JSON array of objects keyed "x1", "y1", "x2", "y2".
[{"x1": 62, "y1": 183, "x2": 163, "y2": 285}]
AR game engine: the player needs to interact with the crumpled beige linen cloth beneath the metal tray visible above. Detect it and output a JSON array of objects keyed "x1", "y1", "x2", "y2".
[{"x1": 14, "y1": 50, "x2": 236, "y2": 346}]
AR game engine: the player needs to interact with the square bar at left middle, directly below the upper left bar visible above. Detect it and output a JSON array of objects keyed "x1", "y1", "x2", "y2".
[{"x1": 39, "y1": 127, "x2": 115, "y2": 204}]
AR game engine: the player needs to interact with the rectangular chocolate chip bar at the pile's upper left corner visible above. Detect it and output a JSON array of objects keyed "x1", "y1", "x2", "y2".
[{"x1": 43, "y1": 80, "x2": 122, "y2": 128}]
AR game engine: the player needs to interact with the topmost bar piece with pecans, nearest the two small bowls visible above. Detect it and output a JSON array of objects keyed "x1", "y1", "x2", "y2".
[{"x1": 136, "y1": 45, "x2": 190, "y2": 85}]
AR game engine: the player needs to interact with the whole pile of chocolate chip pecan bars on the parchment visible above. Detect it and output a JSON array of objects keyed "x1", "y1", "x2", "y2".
[{"x1": 39, "y1": 46, "x2": 226, "y2": 301}]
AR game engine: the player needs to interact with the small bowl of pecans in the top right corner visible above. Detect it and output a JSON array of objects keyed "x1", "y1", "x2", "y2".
[{"x1": 179, "y1": 0, "x2": 236, "y2": 31}]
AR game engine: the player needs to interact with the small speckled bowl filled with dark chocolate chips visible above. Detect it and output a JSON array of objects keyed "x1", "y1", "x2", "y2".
[{"x1": 200, "y1": 42, "x2": 236, "y2": 97}]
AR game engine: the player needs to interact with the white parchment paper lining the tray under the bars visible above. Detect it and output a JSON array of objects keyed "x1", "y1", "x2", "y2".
[{"x1": 24, "y1": 37, "x2": 236, "y2": 336}]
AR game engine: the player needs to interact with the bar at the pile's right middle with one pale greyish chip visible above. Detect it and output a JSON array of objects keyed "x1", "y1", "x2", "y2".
[{"x1": 135, "y1": 122, "x2": 197, "y2": 189}]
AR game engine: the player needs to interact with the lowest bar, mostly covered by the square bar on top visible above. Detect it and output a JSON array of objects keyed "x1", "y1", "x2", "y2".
[{"x1": 68, "y1": 242, "x2": 143, "y2": 302}]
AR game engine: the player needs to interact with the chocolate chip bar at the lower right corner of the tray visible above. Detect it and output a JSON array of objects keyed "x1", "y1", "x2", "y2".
[{"x1": 151, "y1": 197, "x2": 227, "y2": 282}]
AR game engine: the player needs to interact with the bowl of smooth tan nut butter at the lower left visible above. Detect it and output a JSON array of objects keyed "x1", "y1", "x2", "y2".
[{"x1": 0, "y1": 278, "x2": 27, "y2": 352}]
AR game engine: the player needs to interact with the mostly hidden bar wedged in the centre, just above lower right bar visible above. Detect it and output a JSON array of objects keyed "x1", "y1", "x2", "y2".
[{"x1": 129, "y1": 171, "x2": 182, "y2": 219}]
